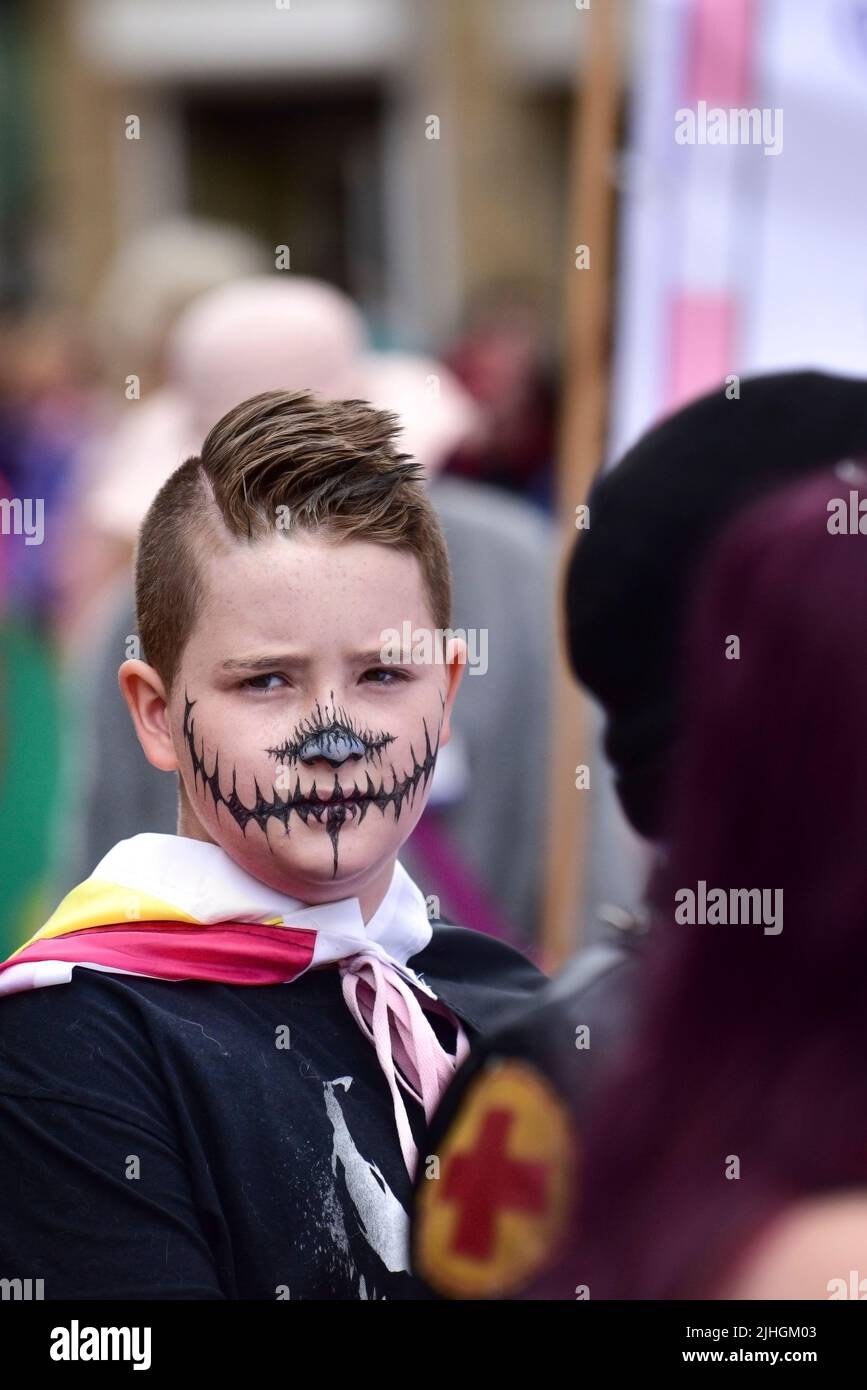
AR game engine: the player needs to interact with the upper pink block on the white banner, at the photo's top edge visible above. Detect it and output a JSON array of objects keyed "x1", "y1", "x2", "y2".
[{"x1": 684, "y1": 0, "x2": 756, "y2": 107}]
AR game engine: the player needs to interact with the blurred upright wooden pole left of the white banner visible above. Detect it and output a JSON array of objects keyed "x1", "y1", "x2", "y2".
[{"x1": 542, "y1": 0, "x2": 621, "y2": 970}]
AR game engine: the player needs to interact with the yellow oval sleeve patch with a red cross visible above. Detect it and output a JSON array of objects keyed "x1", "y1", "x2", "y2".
[{"x1": 415, "y1": 1062, "x2": 575, "y2": 1298}]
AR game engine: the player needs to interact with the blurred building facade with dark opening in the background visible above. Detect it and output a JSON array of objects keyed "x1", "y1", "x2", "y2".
[{"x1": 17, "y1": 0, "x2": 633, "y2": 345}]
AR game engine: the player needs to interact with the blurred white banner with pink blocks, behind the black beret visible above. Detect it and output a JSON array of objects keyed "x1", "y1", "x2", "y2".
[{"x1": 609, "y1": 0, "x2": 867, "y2": 460}]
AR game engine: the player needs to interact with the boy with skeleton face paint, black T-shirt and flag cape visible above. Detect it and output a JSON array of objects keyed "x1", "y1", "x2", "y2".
[{"x1": 0, "y1": 392, "x2": 543, "y2": 1298}]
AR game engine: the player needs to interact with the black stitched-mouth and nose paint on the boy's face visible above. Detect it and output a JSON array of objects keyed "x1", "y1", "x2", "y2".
[{"x1": 183, "y1": 692, "x2": 445, "y2": 878}]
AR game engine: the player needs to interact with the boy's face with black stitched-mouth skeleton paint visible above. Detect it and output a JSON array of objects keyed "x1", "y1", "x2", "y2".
[{"x1": 168, "y1": 534, "x2": 460, "y2": 902}]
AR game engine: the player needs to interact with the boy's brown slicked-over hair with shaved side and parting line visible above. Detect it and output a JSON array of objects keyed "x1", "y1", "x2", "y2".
[{"x1": 135, "y1": 391, "x2": 452, "y2": 694}]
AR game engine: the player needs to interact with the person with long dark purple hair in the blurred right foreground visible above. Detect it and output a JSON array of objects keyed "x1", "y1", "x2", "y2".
[{"x1": 568, "y1": 464, "x2": 867, "y2": 1298}]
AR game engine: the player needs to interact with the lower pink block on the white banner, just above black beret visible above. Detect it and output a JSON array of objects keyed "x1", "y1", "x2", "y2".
[{"x1": 666, "y1": 291, "x2": 736, "y2": 414}]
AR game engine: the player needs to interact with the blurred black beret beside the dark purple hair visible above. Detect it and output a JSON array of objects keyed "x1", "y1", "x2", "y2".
[{"x1": 565, "y1": 371, "x2": 867, "y2": 838}]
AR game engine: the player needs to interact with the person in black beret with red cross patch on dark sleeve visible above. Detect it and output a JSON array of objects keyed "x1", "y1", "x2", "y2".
[{"x1": 413, "y1": 373, "x2": 867, "y2": 1298}]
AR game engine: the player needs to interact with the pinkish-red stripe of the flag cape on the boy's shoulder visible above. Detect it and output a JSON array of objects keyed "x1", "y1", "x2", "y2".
[{"x1": 0, "y1": 922, "x2": 317, "y2": 984}]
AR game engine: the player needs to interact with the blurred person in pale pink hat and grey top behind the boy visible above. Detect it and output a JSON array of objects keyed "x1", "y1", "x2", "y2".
[{"x1": 60, "y1": 277, "x2": 554, "y2": 945}]
